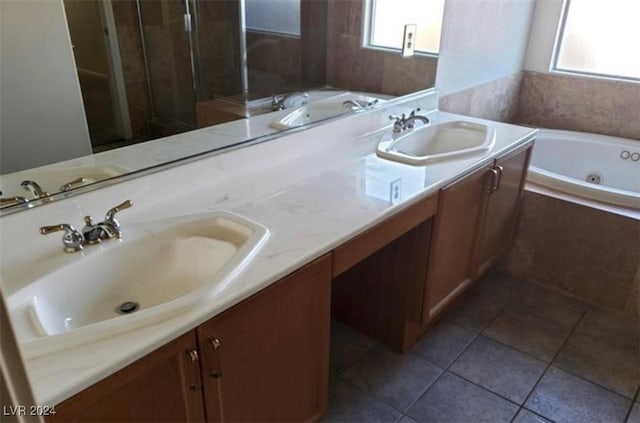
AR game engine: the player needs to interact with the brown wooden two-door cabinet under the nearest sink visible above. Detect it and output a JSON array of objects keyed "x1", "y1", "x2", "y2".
[{"x1": 48, "y1": 255, "x2": 331, "y2": 422}]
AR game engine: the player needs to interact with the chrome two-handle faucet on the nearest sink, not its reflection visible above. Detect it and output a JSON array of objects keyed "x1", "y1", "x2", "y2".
[{"x1": 40, "y1": 200, "x2": 133, "y2": 253}]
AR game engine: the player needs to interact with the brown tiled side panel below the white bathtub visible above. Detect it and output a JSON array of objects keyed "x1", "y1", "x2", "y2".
[{"x1": 498, "y1": 191, "x2": 640, "y2": 316}]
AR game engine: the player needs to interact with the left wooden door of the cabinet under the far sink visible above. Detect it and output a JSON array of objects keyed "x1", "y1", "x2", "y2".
[{"x1": 422, "y1": 167, "x2": 490, "y2": 323}]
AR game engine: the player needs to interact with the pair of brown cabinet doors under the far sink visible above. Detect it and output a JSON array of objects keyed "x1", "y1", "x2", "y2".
[{"x1": 422, "y1": 143, "x2": 532, "y2": 323}]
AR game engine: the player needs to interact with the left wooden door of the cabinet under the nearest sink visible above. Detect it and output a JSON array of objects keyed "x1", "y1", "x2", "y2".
[{"x1": 47, "y1": 332, "x2": 204, "y2": 422}]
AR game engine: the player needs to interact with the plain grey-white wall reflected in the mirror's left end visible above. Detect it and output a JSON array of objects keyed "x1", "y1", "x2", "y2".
[{"x1": 0, "y1": 0, "x2": 91, "y2": 173}]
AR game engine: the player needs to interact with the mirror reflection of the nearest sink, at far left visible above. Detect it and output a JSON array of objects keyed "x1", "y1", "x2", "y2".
[{"x1": 0, "y1": 165, "x2": 129, "y2": 198}]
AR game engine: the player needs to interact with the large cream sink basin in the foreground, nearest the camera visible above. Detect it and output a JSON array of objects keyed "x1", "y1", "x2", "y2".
[{"x1": 8, "y1": 212, "x2": 268, "y2": 356}]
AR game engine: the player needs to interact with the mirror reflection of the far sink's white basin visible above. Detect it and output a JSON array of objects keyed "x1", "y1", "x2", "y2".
[{"x1": 271, "y1": 92, "x2": 384, "y2": 129}]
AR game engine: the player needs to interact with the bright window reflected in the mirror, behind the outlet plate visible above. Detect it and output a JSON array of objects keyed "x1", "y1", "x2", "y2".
[{"x1": 364, "y1": 0, "x2": 444, "y2": 56}]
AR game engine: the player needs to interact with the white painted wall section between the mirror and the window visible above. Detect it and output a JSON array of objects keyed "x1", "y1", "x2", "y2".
[{"x1": 436, "y1": 0, "x2": 535, "y2": 95}]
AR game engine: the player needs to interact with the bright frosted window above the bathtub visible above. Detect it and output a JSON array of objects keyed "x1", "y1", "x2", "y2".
[{"x1": 552, "y1": 0, "x2": 640, "y2": 81}]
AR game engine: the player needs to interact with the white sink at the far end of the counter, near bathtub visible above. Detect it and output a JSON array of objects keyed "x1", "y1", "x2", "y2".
[{"x1": 376, "y1": 121, "x2": 496, "y2": 165}]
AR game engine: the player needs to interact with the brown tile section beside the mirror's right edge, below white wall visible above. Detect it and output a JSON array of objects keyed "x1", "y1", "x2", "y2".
[{"x1": 439, "y1": 72, "x2": 522, "y2": 122}]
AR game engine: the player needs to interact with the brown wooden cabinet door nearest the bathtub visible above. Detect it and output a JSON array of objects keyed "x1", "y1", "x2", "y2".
[{"x1": 473, "y1": 144, "x2": 531, "y2": 277}]
